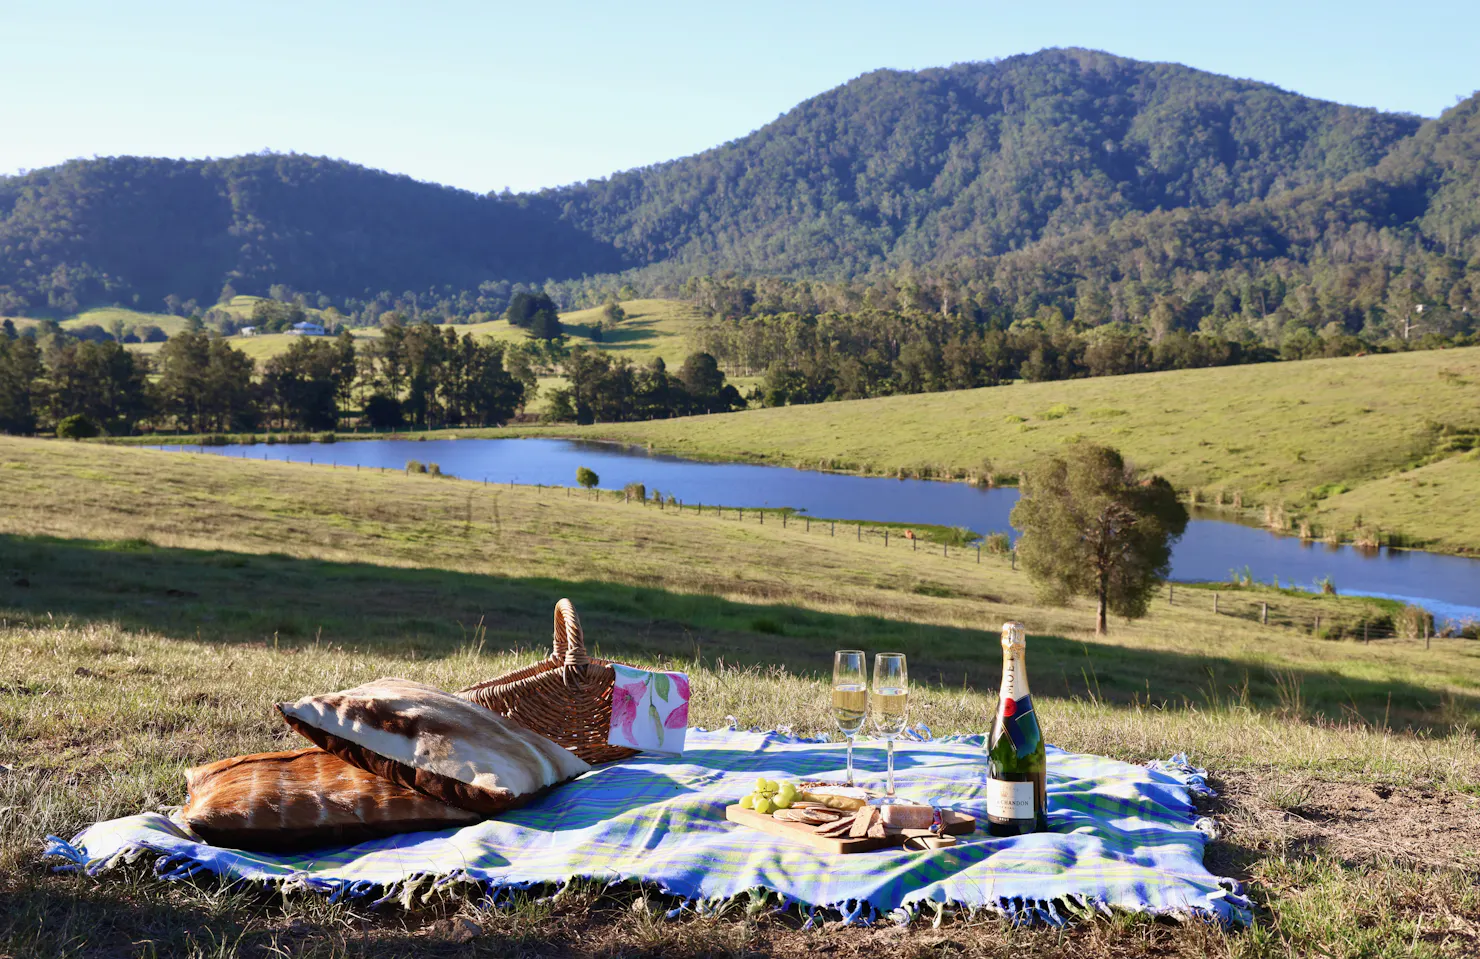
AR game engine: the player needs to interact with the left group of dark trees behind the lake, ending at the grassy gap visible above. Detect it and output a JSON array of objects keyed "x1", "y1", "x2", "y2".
[{"x1": 0, "y1": 321, "x2": 534, "y2": 435}]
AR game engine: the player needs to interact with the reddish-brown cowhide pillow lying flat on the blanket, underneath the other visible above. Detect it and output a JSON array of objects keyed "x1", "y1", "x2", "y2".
[{"x1": 178, "y1": 749, "x2": 482, "y2": 852}]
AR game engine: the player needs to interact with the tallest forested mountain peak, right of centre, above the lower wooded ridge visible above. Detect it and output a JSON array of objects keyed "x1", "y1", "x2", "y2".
[{"x1": 542, "y1": 50, "x2": 1419, "y2": 275}]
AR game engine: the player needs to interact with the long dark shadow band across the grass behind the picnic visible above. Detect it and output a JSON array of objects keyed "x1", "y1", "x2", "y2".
[{"x1": 0, "y1": 536, "x2": 1480, "y2": 728}]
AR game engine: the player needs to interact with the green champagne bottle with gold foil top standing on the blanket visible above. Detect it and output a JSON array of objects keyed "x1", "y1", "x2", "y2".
[{"x1": 987, "y1": 623, "x2": 1048, "y2": 836}]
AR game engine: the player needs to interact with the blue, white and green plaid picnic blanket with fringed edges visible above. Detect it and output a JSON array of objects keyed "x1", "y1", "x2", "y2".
[{"x1": 47, "y1": 730, "x2": 1251, "y2": 923}]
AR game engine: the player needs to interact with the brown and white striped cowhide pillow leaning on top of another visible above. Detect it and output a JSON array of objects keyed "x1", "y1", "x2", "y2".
[{"x1": 278, "y1": 679, "x2": 591, "y2": 815}]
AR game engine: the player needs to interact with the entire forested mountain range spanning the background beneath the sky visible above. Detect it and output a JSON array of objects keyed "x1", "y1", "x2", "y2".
[{"x1": 0, "y1": 50, "x2": 1480, "y2": 318}]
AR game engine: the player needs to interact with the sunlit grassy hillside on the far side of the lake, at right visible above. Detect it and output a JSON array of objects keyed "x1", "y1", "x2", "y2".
[{"x1": 538, "y1": 348, "x2": 1480, "y2": 552}]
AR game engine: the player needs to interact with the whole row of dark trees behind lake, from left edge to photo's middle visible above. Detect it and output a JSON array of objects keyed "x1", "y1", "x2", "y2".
[{"x1": 0, "y1": 311, "x2": 746, "y2": 435}]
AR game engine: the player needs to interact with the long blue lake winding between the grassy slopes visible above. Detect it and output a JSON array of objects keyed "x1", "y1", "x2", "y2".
[{"x1": 158, "y1": 440, "x2": 1480, "y2": 620}]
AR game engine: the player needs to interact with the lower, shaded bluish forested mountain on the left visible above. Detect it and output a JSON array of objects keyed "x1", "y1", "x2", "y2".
[{"x1": 0, "y1": 154, "x2": 623, "y2": 314}]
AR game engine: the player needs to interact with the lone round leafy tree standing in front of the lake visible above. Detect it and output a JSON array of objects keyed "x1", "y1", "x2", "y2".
[{"x1": 1012, "y1": 443, "x2": 1187, "y2": 636}]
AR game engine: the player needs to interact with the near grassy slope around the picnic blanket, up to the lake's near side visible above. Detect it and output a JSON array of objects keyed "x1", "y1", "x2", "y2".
[{"x1": 0, "y1": 438, "x2": 1480, "y2": 958}]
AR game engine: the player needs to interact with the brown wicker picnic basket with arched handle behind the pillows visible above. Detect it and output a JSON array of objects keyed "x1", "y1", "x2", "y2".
[{"x1": 457, "y1": 599, "x2": 638, "y2": 765}]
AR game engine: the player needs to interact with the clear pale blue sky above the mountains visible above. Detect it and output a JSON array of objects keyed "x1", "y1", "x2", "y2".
[{"x1": 0, "y1": 0, "x2": 1480, "y2": 191}]
